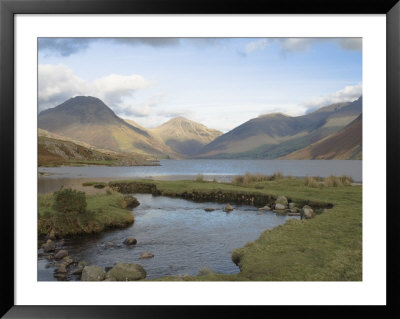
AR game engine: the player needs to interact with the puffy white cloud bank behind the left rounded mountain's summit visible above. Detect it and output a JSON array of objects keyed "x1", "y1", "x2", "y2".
[{"x1": 39, "y1": 64, "x2": 151, "y2": 114}]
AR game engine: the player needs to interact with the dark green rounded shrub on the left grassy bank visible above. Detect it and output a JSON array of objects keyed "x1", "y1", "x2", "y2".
[{"x1": 53, "y1": 188, "x2": 87, "y2": 213}]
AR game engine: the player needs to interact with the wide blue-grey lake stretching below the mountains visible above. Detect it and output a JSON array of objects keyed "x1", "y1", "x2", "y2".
[{"x1": 39, "y1": 160, "x2": 362, "y2": 182}]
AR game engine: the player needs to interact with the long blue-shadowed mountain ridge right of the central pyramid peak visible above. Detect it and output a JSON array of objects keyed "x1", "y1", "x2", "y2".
[{"x1": 197, "y1": 97, "x2": 362, "y2": 159}]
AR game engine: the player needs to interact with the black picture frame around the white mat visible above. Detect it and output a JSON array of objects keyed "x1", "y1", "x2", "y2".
[{"x1": 0, "y1": 0, "x2": 400, "y2": 318}]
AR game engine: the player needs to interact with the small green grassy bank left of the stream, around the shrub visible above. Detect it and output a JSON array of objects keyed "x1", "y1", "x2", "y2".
[{"x1": 38, "y1": 192, "x2": 134, "y2": 237}]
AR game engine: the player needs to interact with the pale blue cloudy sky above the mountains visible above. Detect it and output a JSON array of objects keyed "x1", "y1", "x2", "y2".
[{"x1": 38, "y1": 38, "x2": 362, "y2": 132}]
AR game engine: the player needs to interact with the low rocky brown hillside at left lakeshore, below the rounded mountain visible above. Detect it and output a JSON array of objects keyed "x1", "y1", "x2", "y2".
[{"x1": 38, "y1": 136, "x2": 155, "y2": 166}]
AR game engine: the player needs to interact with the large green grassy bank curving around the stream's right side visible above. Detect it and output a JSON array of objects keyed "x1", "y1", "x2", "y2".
[{"x1": 110, "y1": 178, "x2": 362, "y2": 281}]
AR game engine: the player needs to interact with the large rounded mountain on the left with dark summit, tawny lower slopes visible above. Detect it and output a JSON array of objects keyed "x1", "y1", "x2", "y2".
[{"x1": 38, "y1": 96, "x2": 178, "y2": 158}]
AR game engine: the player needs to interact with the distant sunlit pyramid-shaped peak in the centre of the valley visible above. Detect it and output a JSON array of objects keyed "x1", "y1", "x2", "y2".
[{"x1": 149, "y1": 117, "x2": 222, "y2": 156}]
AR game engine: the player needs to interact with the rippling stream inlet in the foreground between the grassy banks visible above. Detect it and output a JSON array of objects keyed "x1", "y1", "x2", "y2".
[{"x1": 38, "y1": 194, "x2": 299, "y2": 280}]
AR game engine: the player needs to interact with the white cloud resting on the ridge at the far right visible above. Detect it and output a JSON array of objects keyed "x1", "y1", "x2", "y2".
[{"x1": 304, "y1": 84, "x2": 362, "y2": 113}]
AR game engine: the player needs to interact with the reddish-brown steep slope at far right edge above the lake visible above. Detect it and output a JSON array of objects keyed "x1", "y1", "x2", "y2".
[{"x1": 280, "y1": 114, "x2": 362, "y2": 160}]
